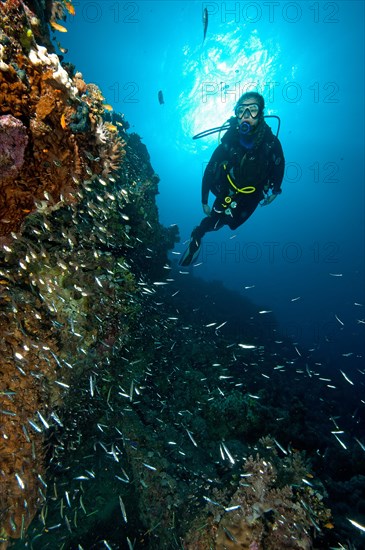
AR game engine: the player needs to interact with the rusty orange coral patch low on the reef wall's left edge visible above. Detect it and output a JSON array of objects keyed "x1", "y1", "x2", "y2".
[{"x1": 0, "y1": 287, "x2": 61, "y2": 538}]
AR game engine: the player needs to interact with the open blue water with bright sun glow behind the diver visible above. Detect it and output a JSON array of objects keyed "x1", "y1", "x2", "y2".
[{"x1": 61, "y1": 0, "x2": 365, "y2": 360}]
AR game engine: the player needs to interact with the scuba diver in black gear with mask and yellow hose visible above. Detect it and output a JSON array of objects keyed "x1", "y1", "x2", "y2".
[{"x1": 179, "y1": 92, "x2": 285, "y2": 266}]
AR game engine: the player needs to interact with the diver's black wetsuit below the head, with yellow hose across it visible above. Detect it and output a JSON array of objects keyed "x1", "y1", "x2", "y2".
[{"x1": 192, "y1": 120, "x2": 285, "y2": 242}]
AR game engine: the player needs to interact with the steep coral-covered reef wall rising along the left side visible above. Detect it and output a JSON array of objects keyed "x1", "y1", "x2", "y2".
[{"x1": 0, "y1": 0, "x2": 174, "y2": 541}]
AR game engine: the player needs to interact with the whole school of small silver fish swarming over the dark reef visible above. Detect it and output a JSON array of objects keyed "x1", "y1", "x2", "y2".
[{"x1": 0, "y1": 2, "x2": 365, "y2": 550}]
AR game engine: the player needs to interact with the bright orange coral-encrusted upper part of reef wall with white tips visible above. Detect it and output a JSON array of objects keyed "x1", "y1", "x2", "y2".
[{"x1": 0, "y1": 0, "x2": 123, "y2": 238}]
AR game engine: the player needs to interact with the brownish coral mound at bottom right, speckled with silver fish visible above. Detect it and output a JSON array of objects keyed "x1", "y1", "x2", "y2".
[{"x1": 184, "y1": 454, "x2": 330, "y2": 550}]
